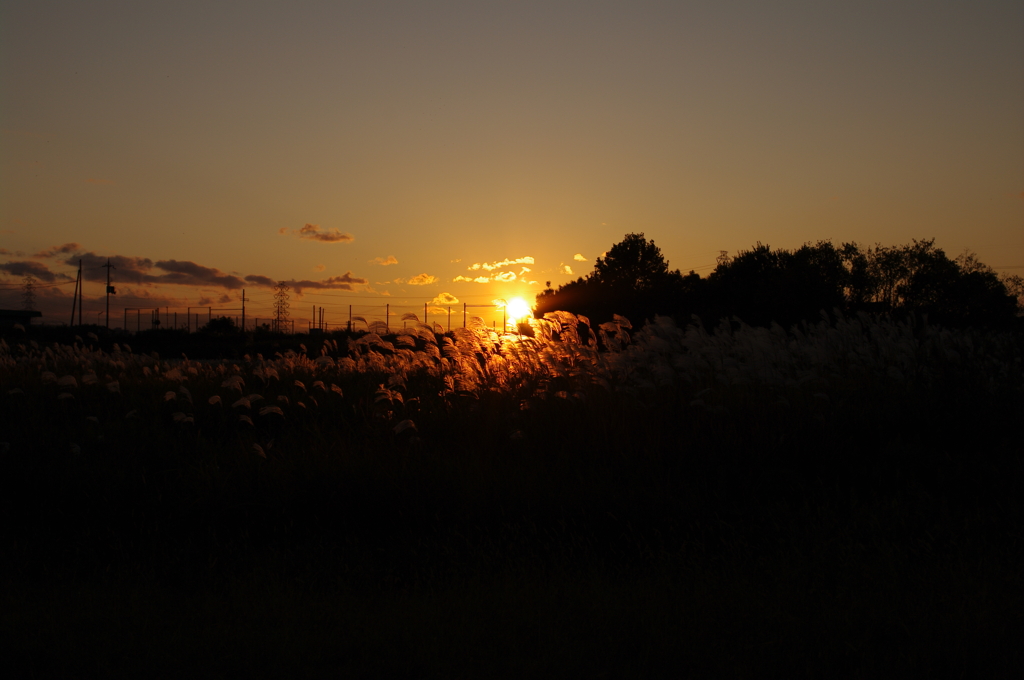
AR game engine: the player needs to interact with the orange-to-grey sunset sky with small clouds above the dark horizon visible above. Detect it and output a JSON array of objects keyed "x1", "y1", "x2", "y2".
[{"x1": 0, "y1": 0, "x2": 1024, "y2": 327}]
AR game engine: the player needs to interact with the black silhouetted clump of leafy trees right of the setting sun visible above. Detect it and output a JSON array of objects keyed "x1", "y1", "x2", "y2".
[{"x1": 536, "y1": 233, "x2": 1024, "y2": 327}]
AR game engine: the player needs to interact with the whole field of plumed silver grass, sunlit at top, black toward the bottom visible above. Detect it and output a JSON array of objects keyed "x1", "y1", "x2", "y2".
[{"x1": 0, "y1": 312, "x2": 1024, "y2": 677}]
